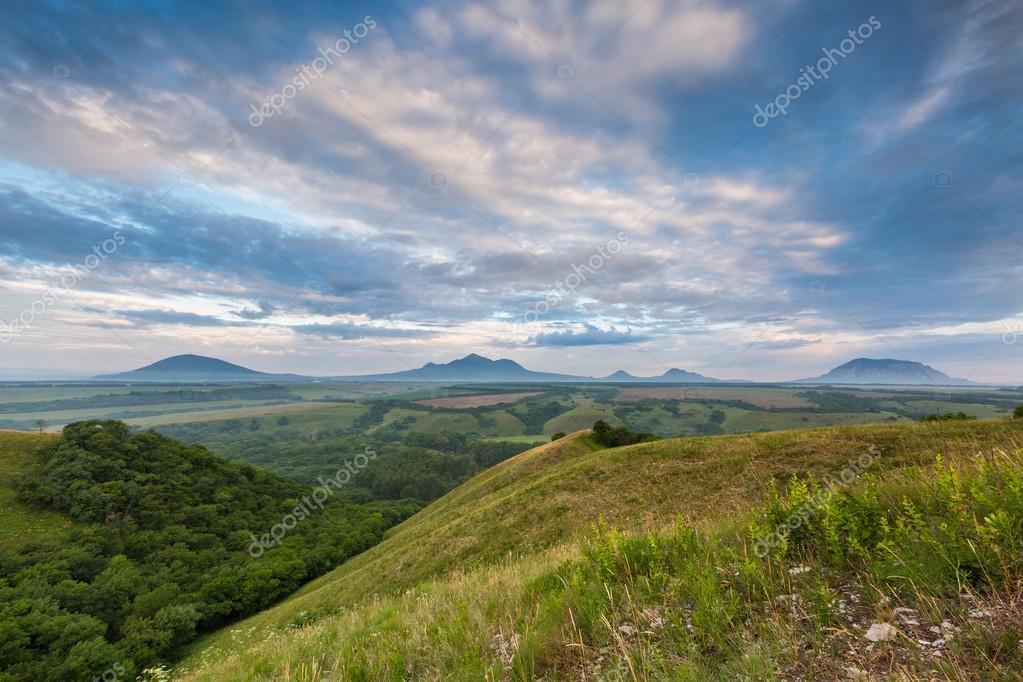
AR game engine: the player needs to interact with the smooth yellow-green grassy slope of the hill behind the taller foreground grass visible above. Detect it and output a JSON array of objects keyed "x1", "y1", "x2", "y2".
[{"x1": 173, "y1": 421, "x2": 1023, "y2": 679}]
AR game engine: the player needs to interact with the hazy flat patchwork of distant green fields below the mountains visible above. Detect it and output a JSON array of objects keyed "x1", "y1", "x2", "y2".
[{"x1": 0, "y1": 382, "x2": 1023, "y2": 438}]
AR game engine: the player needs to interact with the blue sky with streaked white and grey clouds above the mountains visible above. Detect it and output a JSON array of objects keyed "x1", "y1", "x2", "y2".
[{"x1": 0, "y1": 0, "x2": 1023, "y2": 383}]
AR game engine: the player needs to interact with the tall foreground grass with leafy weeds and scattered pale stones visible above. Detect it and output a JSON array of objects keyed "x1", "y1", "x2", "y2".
[{"x1": 180, "y1": 453, "x2": 1023, "y2": 682}]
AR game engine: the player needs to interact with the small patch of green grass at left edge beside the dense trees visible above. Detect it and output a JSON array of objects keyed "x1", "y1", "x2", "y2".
[{"x1": 0, "y1": 431, "x2": 71, "y2": 549}]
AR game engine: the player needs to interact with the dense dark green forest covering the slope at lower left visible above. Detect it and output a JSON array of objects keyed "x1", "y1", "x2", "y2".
[{"x1": 0, "y1": 421, "x2": 420, "y2": 681}]
